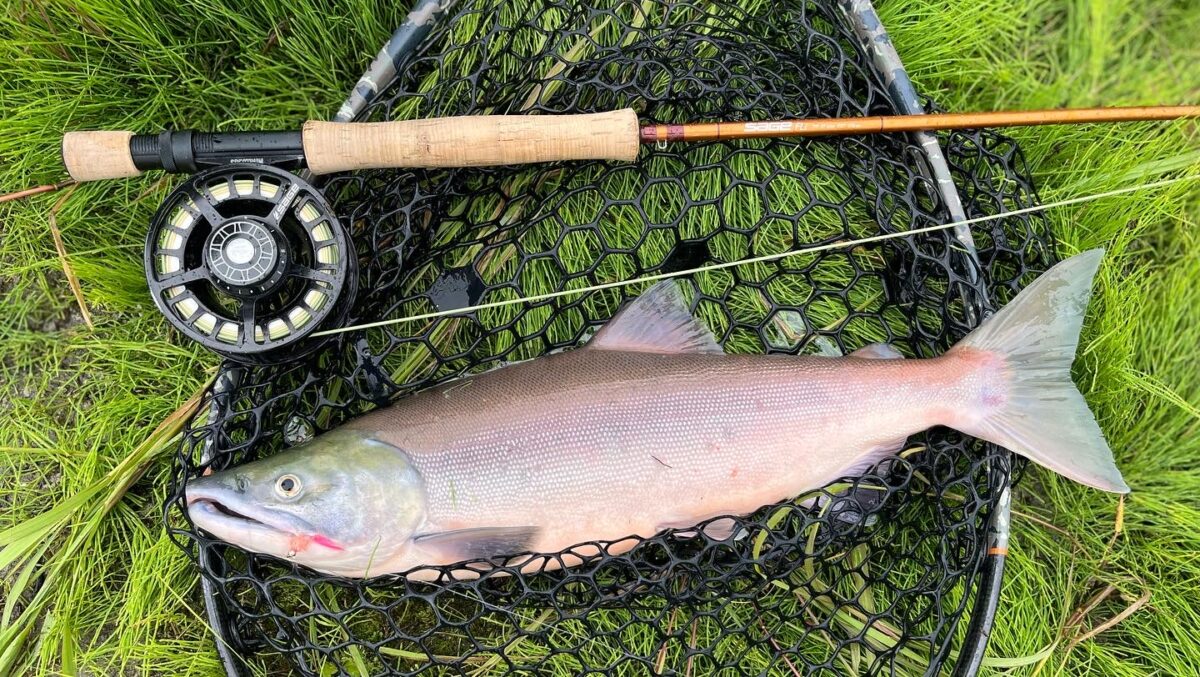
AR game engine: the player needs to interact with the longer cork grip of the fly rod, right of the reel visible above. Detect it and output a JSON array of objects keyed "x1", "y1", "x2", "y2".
[{"x1": 304, "y1": 108, "x2": 638, "y2": 174}]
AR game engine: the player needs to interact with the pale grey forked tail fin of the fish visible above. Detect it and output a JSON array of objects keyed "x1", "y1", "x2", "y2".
[{"x1": 952, "y1": 250, "x2": 1129, "y2": 493}]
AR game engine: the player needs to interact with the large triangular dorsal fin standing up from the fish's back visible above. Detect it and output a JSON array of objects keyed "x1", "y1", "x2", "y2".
[{"x1": 587, "y1": 280, "x2": 725, "y2": 353}]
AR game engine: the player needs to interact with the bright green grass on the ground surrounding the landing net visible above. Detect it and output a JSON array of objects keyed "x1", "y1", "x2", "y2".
[{"x1": 0, "y1": 0, "x2": 1200, "y2": 675}]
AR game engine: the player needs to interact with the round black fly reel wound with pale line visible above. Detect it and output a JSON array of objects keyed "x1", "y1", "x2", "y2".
[{"x1": 145, "y1": 164, "x2": 356, "y2": 363}]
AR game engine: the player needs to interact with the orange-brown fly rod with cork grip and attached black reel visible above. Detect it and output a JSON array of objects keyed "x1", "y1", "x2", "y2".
[{"x1": 13, "y1": 101, "x2": 1200, "y2": 363}]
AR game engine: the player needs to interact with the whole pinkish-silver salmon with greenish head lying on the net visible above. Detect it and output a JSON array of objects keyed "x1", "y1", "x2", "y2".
[{"x1": 185, "y1": 250, "x2": 1129, "y2": 580}]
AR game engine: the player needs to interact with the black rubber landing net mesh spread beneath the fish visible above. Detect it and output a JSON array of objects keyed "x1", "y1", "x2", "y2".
[{"x1": 167, "y1": 0, "x2": 1051, "y2": 675}]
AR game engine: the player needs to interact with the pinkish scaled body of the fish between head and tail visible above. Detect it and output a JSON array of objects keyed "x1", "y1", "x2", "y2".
[{"x1": 355, "y1": 351, "x2": 995, "y2": 565}]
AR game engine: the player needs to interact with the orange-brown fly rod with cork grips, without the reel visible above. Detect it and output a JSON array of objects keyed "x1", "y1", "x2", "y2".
[{"x1": 62, "y1": 106, "x2": 1200, "y2": 181}]
